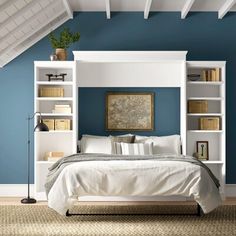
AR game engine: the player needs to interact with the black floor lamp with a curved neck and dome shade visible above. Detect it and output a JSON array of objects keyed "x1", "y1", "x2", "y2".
[{"x1": 21, "y1": 112, "x2": 49, "y2": 204}]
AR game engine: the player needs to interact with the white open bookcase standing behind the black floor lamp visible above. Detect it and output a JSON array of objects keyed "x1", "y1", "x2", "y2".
[{"x1": 34, "y1": 61, "x2": 78, "y2": 200}]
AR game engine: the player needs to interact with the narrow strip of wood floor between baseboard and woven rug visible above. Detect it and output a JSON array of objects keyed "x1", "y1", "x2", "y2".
[{"x1": 0, "y1": 197, "x2": 236, "y2": 205}]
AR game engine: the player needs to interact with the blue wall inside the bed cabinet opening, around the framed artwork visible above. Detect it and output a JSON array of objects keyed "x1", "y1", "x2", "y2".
[{"x1": 79, "y1": 88, "x2": 180, "y2": 135}]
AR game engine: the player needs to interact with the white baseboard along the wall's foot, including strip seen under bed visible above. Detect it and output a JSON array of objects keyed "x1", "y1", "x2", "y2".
[{"x1": 0, "y1": 184, "x2": 236, "y2": 201}]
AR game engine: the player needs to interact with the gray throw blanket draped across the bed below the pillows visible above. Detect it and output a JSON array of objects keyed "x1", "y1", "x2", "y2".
[{"x1": 44, "y1": 153, "x2": 220, "y2": 196}]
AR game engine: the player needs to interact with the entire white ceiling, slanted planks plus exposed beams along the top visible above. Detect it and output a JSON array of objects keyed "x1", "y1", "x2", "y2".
[{"x1": 0, "y1": 0, "x2": 236, "y2": 67}]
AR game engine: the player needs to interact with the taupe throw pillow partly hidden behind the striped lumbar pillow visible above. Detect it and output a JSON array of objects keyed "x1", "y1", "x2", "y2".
[{"x1": 110, "y1": 134, "x2": 135, "y2": 154}]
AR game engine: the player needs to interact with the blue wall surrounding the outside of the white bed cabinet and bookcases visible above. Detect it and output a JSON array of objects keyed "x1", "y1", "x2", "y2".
[{"x1": 0, "y1": 12, "x2": 236, "y2": 184}]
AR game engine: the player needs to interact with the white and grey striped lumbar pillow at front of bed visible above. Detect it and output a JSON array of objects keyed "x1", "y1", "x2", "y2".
[{"x1": 121, "y1": 143, "x2": 153, "y2": 155}]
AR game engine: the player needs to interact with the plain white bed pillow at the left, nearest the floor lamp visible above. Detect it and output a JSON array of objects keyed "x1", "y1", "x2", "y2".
[{"x1": 81, "y1": 135, "x2": 112, "y2": 154}]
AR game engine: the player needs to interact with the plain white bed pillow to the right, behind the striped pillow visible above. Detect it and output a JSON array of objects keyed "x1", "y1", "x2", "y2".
[{"x1": 134, "y1": 135, "x2": 181, "y2": 155}]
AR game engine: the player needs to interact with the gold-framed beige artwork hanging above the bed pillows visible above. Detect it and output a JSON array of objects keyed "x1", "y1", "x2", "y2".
[{"x1": 106, "y1": 92, "x2": 154, "y2": 131}]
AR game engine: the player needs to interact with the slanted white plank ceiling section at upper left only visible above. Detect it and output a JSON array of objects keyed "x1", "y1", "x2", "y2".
[{"x1": 0, "y1": 0, "x2": 72, "y2": 67}]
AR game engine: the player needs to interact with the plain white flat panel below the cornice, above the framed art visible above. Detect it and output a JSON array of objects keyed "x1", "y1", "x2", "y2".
[{"x1": 77, "y1": 62, "x2": 183, "y2": 87}]
